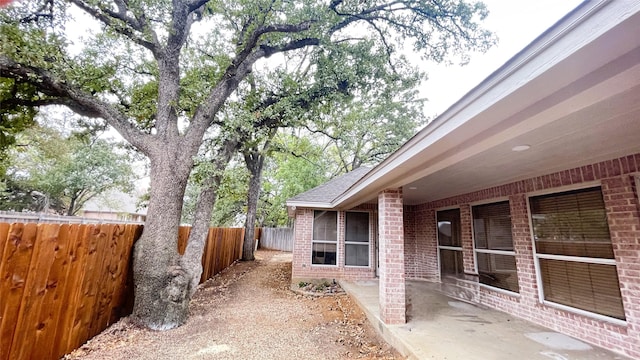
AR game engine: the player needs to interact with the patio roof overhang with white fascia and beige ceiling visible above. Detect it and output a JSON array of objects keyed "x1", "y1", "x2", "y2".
[{"x1": 334, "y1": 1, "x2": 640, "y2": 208}]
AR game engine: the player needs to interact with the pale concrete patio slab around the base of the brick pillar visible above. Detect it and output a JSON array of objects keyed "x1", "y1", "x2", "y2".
[{"x1": 340, "y1": 280, "x2": 628, "y2": 360}]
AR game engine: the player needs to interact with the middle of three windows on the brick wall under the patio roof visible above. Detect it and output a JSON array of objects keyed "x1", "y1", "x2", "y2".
[{"x1": 473, "y1": 201, "x2": 519, "y2": 292}]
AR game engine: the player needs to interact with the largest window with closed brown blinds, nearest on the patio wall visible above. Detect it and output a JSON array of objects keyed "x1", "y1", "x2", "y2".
[{"x1": 530, "y1": 187, "x2": 625, "y2": 320}]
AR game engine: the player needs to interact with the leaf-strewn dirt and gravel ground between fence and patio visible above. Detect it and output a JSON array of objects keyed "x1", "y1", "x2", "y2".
[{"x1": 64, "y1": 250, "x2": 403, "y2": 360}]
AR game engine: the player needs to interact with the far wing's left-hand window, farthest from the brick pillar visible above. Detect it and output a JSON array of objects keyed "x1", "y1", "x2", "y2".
[{"x1": 311, "y1": 210, "x2": 338, "y2": 265}]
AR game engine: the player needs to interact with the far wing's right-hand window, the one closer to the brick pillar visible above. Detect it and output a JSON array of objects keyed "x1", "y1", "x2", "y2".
[{"x1": 344, "y1": 212, "x2": 369, "y2": 266}]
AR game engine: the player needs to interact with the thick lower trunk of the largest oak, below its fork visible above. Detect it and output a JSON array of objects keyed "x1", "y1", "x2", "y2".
[{"x1": 132, "y1": 152, "x2": 193, "y2": 330}]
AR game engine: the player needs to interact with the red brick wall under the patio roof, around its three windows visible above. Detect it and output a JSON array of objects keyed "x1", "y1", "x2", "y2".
[{"x1": 407, "y1": 154, "x2": 640, "y2": 358}]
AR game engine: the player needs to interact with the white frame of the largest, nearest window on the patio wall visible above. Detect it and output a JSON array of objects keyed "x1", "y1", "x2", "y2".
[{"x1": 526, "y1": 181, "x2": 627, "y2": 326}]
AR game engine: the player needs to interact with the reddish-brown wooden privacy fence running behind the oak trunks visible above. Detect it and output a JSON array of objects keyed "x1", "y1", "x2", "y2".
[{"x1": 0, "y1": 223, "x2": 244, "y2": 360}]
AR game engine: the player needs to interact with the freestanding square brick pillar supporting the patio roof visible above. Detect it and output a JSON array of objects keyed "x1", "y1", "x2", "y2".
[{"x1": 378, "y1": 189, "x2": 406, "y2": 324}]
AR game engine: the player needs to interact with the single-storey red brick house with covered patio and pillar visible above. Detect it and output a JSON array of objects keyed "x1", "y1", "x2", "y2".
[{"x1": 287, "y1": 1, "x2": 640, "y2": 358}]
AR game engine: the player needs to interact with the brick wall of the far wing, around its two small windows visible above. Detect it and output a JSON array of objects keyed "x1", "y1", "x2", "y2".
[{"x1": 291, "y1": 204, "x2": 378, "y2": 284}]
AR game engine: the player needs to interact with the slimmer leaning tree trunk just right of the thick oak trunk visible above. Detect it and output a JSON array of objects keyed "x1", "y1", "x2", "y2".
[{"x1": 180, "y1": 139, "x2": 238, "y2": 297}]
